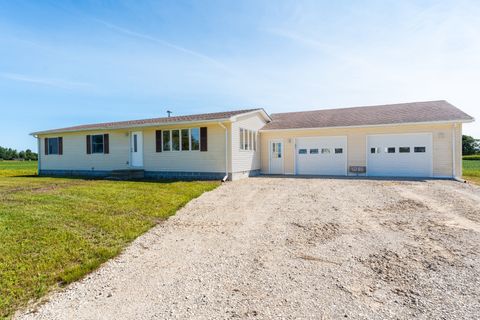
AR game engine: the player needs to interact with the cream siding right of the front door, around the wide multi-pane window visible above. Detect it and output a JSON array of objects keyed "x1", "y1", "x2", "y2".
[{"x1": 143, "y1": 123, "x2": 230, "y2": 175}]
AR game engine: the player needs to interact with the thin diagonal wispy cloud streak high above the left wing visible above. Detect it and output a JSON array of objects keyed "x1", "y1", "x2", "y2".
[{"x1": 94, "y1": 19, "x2": 229, "y2": 71}]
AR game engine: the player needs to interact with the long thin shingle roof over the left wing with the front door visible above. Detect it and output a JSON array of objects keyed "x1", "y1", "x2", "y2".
[{"x1": 32, "y1": 108, "x2": 263, "y2": 134}]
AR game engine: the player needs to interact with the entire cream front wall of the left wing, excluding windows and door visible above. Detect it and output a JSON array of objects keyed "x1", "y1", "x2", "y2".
[{"x1": 39, "y1": 123, "x2": 230, "y2": 177}]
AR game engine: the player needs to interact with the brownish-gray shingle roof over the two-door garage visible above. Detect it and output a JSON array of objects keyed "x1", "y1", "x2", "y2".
[{"x1": 262, "y1": 100, "x2": 474, "y2": 130}]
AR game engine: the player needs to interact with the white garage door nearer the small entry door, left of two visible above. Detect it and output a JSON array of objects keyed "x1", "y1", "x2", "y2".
[{"x1": 295, "y1": 137, "x2": 347, "y2": 176}]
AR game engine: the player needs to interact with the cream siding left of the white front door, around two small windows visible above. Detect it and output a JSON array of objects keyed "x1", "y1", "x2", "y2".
[{"x1": 39, "y1": 130, "x2": 130, "y2": 171}]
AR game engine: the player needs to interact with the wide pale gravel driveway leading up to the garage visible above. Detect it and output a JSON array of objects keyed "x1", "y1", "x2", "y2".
[{"x1": 17, "y1": 177, "x2": 480, "y2": 319}]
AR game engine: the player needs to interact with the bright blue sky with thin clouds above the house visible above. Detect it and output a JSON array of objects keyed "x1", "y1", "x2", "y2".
[{"x1": 0, "y1": 0, "x2": 480, "y2": 149}]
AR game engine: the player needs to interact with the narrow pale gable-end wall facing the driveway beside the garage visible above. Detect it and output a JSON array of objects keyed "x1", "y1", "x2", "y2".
[{"x1": 231, "y1": 113, "x2": 266, "y2": 175}]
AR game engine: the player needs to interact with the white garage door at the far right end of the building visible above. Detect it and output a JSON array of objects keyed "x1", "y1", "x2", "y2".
[{"x1": 367, "y1": 133, "x2": 432, "y2": 177}]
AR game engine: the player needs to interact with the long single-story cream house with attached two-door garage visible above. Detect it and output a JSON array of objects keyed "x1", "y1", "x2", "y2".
[{"x1": 32, "y1": 101, "x2": 474, "y2": 180}]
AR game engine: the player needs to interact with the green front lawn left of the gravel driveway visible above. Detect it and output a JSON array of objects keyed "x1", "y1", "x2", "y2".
[{"x1": 0, "y1": 161, "x2": 219, "y2": 318}]
